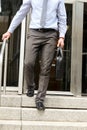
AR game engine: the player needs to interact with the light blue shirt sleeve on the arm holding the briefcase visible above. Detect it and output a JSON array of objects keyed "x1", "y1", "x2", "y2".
[{"x1": 57, "y1": 0, "x2": 67, "y2": 37}]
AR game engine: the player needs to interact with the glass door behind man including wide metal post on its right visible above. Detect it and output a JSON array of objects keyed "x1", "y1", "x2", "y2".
[{"x1": 26, "y1": 0, "x2": 84, "y2": 96}]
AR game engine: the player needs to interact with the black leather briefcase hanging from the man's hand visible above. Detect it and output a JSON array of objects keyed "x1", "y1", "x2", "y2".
[{"x1": 56, "y1": 47, "x2": 63, "y2": 80}]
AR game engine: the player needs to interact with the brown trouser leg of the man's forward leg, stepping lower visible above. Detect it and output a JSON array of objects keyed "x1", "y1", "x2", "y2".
[{"x1": 36, "y1": 31, "x2": 57, "y2": 109}]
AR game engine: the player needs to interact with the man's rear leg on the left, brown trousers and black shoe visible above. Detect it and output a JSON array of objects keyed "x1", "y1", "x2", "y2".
[{"x1": 24, "y1": 30, "x2": 39, "y2": 97}]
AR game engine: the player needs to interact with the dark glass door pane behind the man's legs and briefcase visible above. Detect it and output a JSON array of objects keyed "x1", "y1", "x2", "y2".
[{"x1": 35, "y1": 1, "x2": 74, "y2": 94}]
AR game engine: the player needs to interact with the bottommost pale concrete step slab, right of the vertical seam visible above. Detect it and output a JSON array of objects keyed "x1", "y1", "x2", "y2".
[{"x1": 22, "y1": 121, "x2": 87, "y2": 130}]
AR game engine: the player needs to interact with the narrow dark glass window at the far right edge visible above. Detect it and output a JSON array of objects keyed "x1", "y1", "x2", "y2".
[{"x1": 82, "y1": 3, "x2": 87, "y2": 93}]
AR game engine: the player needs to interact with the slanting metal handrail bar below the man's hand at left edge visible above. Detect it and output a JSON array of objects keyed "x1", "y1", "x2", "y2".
[{"x1": 0, "y1": 40, "x2": 7, "y2": 95}]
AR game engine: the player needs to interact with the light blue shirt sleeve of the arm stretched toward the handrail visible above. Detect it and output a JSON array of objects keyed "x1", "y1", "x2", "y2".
[{"x1": 8, "y1": 0, "x2": 31, "y2": 33}]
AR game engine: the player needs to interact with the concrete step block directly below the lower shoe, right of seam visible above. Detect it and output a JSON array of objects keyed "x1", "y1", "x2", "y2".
[{"x1": 22, "y1": 108, "x2": 87, "y2": 122}]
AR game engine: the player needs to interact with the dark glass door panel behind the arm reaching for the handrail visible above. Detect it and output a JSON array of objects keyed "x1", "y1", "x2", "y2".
[{"x1": 0, "y1": 0, "x2": 22, "y2": 90}]
